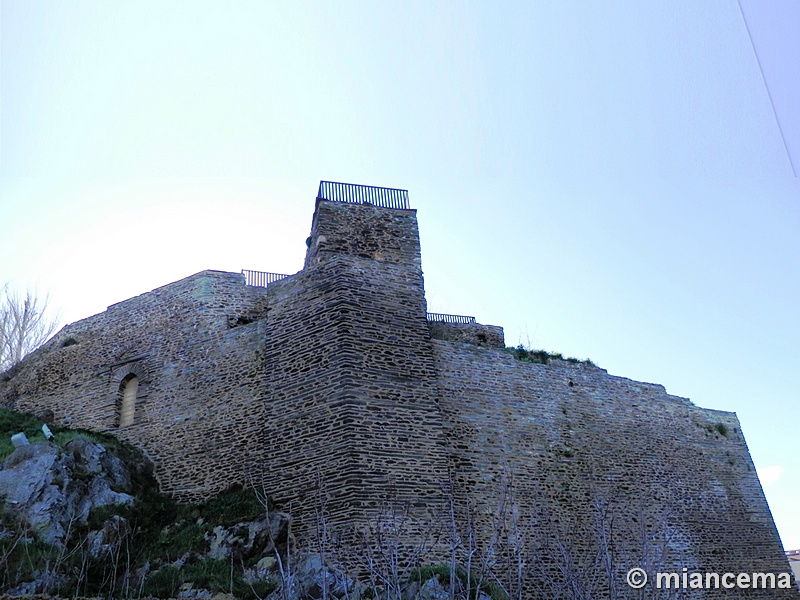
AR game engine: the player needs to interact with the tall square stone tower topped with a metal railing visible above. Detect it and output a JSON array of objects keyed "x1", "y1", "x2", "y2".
[{"x1": 256, "y1": 183, "x2": 448, "y2": 522}]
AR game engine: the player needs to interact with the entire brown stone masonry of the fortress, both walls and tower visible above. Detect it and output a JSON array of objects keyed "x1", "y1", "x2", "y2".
[{"x1": 0, "y1": 186, "x2": 796, "y2": 598}]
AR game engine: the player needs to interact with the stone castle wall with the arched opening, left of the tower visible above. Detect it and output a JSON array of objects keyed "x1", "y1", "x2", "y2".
[{"x1": 0, "y1": 271, "x2": 268, "y2": 500}]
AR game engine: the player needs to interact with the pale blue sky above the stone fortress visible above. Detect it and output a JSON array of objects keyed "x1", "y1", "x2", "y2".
[{"x1": 0, "y1": 0, "x2": 800, "y2": 549}]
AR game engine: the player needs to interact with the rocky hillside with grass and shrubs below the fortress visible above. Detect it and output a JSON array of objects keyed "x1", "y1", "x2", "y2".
[{"x1": 0, "y1": 408, "x2": 505, "y2": 600}]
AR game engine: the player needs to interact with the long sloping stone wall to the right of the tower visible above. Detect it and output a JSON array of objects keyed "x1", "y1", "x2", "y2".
[{"x1": 433, "y1": 340, "x2": 793, "y2": 598}]
